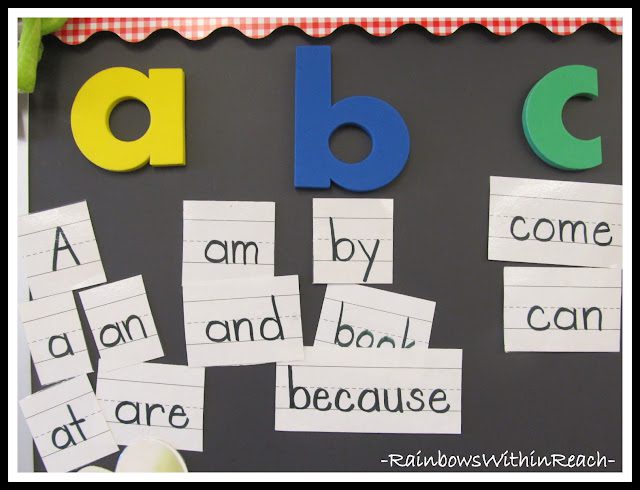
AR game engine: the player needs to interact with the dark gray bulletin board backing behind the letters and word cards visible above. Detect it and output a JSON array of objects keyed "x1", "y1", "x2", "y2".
[{"x1": 29, "y1": 25, "x2": 622, "y2": 471}]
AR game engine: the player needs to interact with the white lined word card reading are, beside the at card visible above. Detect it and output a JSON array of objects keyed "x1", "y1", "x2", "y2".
[{"x1": 96, "y1": 362, "x2": 204, "y2": 451}]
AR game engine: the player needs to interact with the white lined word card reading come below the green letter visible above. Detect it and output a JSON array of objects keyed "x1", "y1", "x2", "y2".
[{"x1": 489, "y1": 177, "x2": 622, "y2": 268}]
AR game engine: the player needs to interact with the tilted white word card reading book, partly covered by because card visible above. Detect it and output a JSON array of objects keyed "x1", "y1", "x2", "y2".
[{"x1": 315, "y1": 284, "x2": 436, "y2": 349}]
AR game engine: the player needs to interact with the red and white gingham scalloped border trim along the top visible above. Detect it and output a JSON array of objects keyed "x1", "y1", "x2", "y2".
[{"x1": 54, "y1": 17, "x2": 622, "y2": 44}]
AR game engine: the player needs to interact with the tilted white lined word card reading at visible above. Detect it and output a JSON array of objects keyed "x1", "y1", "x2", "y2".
[{"x1": 20, "y1": 374, "x2": 118, "y2": 472}]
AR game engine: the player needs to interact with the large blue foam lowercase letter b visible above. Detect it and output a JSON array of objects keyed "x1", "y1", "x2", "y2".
[{"x1": 294, "y1": 46, "x2": 409, "y2": 192}]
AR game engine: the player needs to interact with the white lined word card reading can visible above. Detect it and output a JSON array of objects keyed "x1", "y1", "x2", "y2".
[{"x1": 504, "y1": 267, "x2": 622, "y2": 352}]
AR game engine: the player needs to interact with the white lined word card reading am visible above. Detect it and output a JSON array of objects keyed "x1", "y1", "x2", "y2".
[{"x1": 182, "y1": 201, "x2": 276, "y2": 285}]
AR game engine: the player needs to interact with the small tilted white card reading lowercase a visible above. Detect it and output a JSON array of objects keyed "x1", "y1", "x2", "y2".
[{"x1": 20, "y1": 292, "x2": 93, "y2": 385}]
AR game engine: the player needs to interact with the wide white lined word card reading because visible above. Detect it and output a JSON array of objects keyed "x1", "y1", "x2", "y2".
[{"x1": 275, "y1": 347, "x2": 462, "y2": 434}]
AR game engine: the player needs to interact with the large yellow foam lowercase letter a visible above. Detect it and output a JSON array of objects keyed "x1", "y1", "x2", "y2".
[{"x1": 71, "y1": 67, "x2": 186, "y2": 172}]
